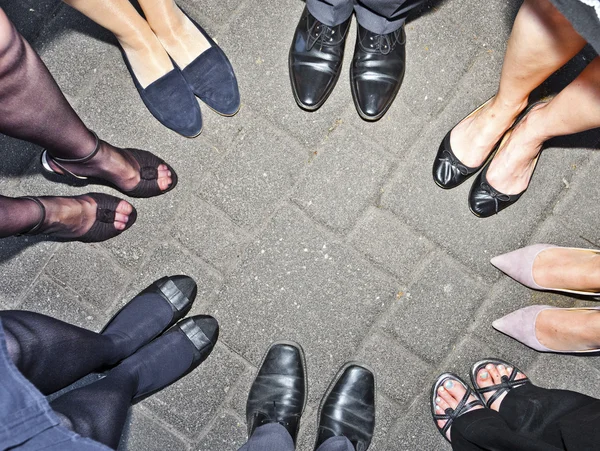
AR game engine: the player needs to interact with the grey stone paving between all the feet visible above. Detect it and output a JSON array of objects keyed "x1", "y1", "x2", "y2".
[{"x1": 0, "y1": 0, "x2": 600, "y2": 451}]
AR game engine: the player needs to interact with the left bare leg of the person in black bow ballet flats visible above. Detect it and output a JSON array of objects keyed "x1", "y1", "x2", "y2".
[{"x1": 450, "y1": 0, "x2": 585, "y2": 168}]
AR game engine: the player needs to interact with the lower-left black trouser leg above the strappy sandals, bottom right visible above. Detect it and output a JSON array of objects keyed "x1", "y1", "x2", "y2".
[{"x1": 450, "y1": 409, "x2": 563, "y2": 451}]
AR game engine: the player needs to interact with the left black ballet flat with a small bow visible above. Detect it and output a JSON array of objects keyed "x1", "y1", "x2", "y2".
[{"x1": 432, "y1": 97, "x2": 494, "y2": 189}]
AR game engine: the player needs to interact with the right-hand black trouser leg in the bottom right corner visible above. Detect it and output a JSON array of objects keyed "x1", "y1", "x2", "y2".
[{"x1": 499, "y1": 384, "x2": 600, "y2": 450}]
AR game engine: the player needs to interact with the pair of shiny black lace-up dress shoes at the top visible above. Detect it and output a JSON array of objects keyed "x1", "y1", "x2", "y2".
[{"x1": 288, "y1": 8, "x2": 406, "y2": 121}]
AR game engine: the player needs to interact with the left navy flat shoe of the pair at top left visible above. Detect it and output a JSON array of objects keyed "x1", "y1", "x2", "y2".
[{"x1": 121, "y1": 49, "x2": 202, "y2": 138}]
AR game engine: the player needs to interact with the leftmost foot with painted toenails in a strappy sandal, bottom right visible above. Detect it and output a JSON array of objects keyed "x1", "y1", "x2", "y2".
[{"x1": 433, "y1": 375, "x2": 483, "y2": 441}]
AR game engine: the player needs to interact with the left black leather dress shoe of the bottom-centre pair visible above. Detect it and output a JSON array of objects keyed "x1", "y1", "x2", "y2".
[{"x1": 246, "y1": 342, "x2": 307, "y2": 443}]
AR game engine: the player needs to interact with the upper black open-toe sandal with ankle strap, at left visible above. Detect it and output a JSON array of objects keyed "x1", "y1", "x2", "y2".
[{"x1": 41, "y1": 130, "x2": 177, "y2": 198}]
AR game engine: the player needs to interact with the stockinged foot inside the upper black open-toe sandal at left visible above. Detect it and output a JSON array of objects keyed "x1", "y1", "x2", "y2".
[{"x1": 47, "y1": 140, "x2": 174, "y2": 197}]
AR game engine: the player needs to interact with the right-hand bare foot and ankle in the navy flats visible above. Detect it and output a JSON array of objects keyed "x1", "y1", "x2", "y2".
[{"x1": 151, "y1": 2, "x2": 211, "y2": 70}]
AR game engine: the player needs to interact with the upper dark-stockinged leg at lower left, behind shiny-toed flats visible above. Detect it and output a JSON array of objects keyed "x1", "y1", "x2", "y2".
[{"x1": 0, "y1": 310, "x2": 124, "y2": 395}]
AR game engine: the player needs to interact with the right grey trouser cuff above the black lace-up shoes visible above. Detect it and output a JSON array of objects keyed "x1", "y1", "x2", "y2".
[{"x1": 356, "y1": 0, "x2": 424, "y2": 34}]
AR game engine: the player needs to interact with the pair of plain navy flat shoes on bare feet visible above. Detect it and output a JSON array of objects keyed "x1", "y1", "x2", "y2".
[{"x1": 121, "y1": 8, "x2": 240, "y2": 138}]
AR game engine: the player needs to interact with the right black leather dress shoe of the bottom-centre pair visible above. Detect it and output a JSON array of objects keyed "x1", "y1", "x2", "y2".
[{"x1": 315, "y1": 363, "x2": 375, "y2": 451}]
